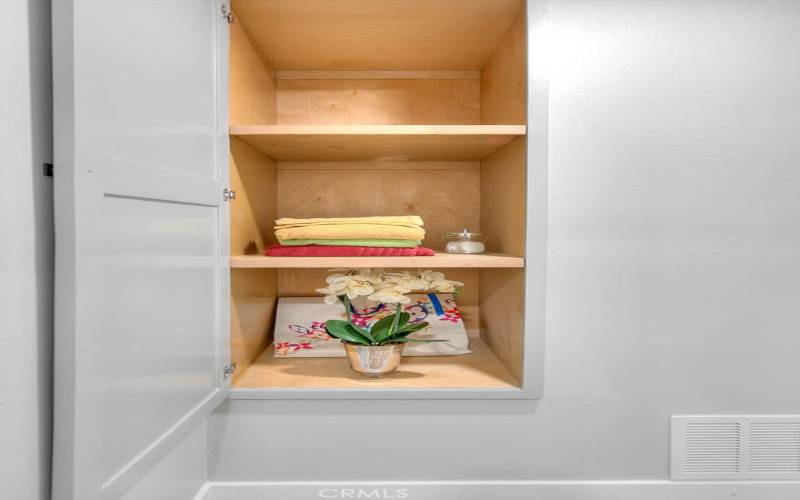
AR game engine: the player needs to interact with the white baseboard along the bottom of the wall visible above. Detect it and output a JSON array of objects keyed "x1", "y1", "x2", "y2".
[{"x1": 195, "y1": 481, "x2": 800, "y2": 500}]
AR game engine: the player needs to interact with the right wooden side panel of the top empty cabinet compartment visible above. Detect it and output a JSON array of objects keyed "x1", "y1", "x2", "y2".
[{"x1": 481, "y1": 9, "x2": 528, "y2": 124}]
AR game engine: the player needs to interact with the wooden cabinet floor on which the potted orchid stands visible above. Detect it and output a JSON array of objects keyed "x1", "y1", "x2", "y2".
[{"x1": 233, "y1": 338, "x2": 519, "y2": 389}]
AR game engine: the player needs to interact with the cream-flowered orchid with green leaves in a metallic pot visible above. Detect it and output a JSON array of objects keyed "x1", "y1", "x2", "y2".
[{"x1": 317, "y1": 268, "x2": 464, "y2": 377}]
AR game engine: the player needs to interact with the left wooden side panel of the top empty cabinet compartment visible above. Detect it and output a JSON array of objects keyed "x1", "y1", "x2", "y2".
[{"x1": 229, "y1": 9, "x2": 277, "y2": 124}]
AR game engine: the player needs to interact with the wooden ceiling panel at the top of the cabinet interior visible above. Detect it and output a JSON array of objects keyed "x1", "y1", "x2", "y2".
[{"x1": 233, "y1": 0, "x2": 523, "y2": 70}]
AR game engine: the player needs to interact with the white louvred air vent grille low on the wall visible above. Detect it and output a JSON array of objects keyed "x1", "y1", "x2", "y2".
[{"x1": 672, "y1": 415, "x2": 800, "y2": 479}]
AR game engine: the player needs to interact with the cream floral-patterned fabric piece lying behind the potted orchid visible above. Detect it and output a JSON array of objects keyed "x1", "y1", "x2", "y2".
[{"x1": 273, "y1": 293, "x2": 470, "y2": 358}]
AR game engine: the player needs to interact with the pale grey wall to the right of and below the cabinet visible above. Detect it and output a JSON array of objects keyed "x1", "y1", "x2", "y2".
[{"x1": 209, "y1": 0, "x2": 800, "y2": 481}]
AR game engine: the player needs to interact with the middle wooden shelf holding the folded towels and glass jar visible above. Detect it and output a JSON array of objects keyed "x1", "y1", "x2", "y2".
[{"x1": 231, "y1": 253, "x2": 525, "y2": 269}]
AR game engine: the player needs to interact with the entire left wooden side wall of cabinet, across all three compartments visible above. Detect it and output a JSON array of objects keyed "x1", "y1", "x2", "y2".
[{"x1": 229, "y1": 13, "x2": 278, "y2": 381}]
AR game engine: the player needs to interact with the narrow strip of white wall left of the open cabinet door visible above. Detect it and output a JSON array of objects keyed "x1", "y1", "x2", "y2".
[{"x1": 0, "y1": 0, "x2": 53, "y2": 500}]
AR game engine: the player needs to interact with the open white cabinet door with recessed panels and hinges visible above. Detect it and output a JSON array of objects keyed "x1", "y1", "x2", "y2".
[{"x1": 53, "y1": 0, "x2": 229, "y2": 500}]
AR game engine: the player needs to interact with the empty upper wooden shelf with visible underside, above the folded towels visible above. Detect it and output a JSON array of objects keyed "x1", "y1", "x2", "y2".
[{"x1": 230, "y1": 125, "x2": 526, "y2": 161}]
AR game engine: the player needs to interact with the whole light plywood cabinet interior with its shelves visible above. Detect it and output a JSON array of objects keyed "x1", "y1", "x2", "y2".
[{"x1": 230, "y1": 0, "x2": 528, "y2": 397}]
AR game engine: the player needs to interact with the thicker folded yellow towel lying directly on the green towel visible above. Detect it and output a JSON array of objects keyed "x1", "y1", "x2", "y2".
[{"x1": 275, "y1": 223, "x2": 425, "y2": 241}]
